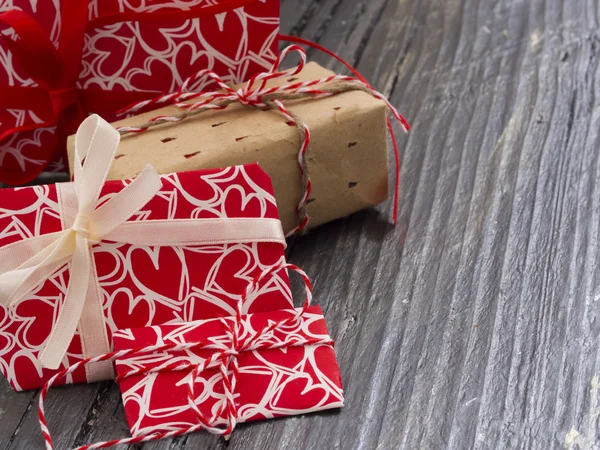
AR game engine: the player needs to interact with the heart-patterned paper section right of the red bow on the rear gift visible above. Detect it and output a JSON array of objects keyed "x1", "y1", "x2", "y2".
[{"x1": 79, "y1": 0, "x2": 279, "y2": 92}]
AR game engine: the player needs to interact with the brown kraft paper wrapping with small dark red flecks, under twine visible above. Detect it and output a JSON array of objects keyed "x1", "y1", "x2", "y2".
[{"x1": 68, "y1": 63, "x2": 388, "y2": 233}]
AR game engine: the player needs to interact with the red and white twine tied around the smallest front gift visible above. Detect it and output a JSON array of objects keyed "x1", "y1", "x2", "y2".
[{"x1": 38, "y1": 264, "x2": 333, "y2": 450}]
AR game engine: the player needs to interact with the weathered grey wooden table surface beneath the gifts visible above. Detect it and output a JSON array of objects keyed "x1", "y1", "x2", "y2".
[{"x1": 0, "y1": 0, "x2": 600, "y2": 450}]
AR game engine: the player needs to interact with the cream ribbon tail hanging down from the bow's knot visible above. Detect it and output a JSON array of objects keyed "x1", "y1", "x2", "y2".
[{"x1": 40, "y1": 235, "x2": 96, "y2": 369}]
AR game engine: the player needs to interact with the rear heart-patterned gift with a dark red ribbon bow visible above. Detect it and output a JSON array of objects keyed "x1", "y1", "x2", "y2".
[{"x1": 0, "y1": 0, "x2": 279, "y2": 184}]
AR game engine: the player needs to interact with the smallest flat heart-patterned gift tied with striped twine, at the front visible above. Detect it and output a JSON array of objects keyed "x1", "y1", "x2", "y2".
[{"x1": 114, "y1": 306, "x2": 344, "y2": 438}]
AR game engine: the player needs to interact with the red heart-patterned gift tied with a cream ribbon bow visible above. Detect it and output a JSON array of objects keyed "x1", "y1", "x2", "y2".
[{"x1": 0, "y1": 116, "x2": 291, "y2": 390}]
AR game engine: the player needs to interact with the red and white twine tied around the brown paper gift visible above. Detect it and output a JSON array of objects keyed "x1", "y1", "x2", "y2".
[{"x1": 118, "y1": 45, "x2": 410, "y2": 236}]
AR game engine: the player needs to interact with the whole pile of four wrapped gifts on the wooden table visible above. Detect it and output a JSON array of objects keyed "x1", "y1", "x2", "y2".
[{"x1": 0, "y1": 0, "x2": 406, "y2": 447}]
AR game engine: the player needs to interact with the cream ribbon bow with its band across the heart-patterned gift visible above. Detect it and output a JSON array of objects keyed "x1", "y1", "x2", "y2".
[{"x1": 0, "y1": 115, "x2": 285, "y2": 369}]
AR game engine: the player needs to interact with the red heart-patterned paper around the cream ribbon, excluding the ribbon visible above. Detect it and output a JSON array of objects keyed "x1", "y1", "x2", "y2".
[{"x1": 0, "y1": 164, "x2": 292, "y2": 391}]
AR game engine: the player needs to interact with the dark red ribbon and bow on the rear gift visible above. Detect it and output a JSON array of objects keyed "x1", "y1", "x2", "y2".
[{"x1": 0, "y1": 0, "x2": 259, "y2": 184}]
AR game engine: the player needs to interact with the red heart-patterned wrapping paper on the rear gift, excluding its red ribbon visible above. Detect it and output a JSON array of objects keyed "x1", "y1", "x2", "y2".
[{"x1": 0, "y1": 0, "x2": 279, "y2": 184}]
